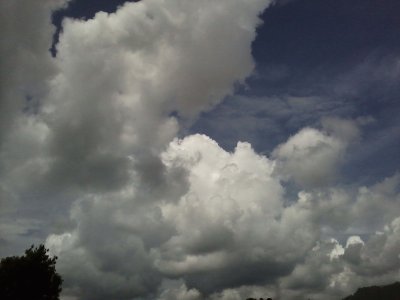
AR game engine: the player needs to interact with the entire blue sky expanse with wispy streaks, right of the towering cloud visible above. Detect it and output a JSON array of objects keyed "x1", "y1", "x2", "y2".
[{"x1": 193, "y1": 1, "x2": 400, "y2": 183}]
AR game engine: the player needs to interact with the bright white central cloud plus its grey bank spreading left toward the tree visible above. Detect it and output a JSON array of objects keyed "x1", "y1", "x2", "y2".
[{"x1": 47, "y1": 135, "x2": 318, "y2": 299}]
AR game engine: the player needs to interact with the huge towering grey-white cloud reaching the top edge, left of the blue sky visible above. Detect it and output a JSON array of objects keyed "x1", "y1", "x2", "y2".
[{"x1": 43, "y1": 1, "x2": 268, "y2": 192}]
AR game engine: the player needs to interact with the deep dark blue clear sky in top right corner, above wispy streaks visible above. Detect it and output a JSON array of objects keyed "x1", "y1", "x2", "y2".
[{"x1": 253, "y1": 0, "x2": 400, "y2": 94}]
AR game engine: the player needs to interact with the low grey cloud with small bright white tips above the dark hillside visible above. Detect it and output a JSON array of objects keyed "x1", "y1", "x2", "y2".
[{"x1": 281, "y1": 219, "x2": 400, "y2": 299}]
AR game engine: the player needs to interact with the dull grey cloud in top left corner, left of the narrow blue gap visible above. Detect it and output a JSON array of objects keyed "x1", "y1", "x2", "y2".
[{"x1": 0, "y1": 0, "x2": 67, "y2": 145}]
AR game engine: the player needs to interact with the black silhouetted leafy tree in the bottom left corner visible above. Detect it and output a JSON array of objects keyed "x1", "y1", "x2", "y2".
[{"x1": 0, "y1": 245, "x2": 62, "y2": 300}]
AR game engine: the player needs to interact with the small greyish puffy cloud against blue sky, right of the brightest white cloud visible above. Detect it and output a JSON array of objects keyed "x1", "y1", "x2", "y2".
[{"x1": 272, "y1": 118, "x2": 359, "y2": 188}]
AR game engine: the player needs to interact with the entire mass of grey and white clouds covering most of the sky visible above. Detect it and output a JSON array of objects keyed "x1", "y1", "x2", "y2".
[{"x1": 0, "y1": 0, "x2": 400, "y2": 300}]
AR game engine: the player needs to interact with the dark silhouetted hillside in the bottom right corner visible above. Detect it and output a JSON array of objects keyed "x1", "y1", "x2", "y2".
[{"x1": 343, "y1": 282, "x2": 400, "y2": 300}]
